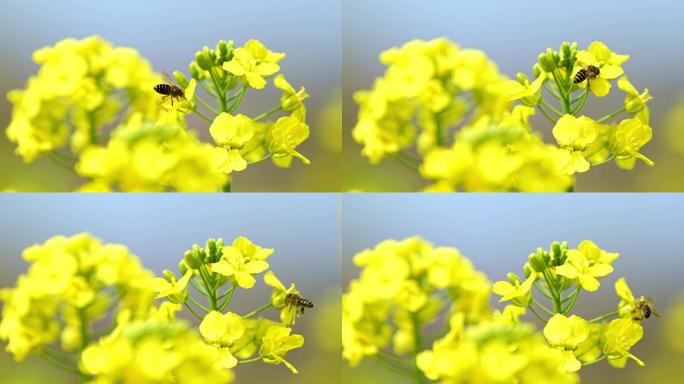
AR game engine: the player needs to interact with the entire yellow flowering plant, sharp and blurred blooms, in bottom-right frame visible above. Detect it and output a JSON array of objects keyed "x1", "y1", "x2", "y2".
[{"x1": 342, "y1": 237, "x2": 648, "y2": 383}]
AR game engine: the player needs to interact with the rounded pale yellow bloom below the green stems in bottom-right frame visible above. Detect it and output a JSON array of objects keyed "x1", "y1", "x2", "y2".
[{"x1": 544, "y1": 314, "x2": 589, "y2": 372}]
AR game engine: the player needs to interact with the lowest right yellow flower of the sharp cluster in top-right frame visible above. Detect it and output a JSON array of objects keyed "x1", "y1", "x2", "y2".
[{"x1": 613, "y1": 119, "x2": 654, "y2": 169}]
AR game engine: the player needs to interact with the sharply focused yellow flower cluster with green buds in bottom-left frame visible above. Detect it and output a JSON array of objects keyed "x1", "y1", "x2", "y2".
[{"x1": 153, "y1": 237, "x2": 304, "y2": 373}]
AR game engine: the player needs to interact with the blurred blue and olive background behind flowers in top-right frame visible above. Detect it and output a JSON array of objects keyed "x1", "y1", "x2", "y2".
[{"x1": 342, "y1": 0, "x2": 684, "y2": 191}]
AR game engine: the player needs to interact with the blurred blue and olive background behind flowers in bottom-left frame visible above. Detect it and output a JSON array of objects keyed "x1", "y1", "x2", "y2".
[{"x1": 0, "y1": 194, "x2": 341, "y2": 384}]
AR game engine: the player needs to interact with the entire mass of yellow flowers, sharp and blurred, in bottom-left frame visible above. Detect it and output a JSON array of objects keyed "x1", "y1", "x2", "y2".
[{"x1": 0, "y1": 233, "x2": 304, "y2": 384}]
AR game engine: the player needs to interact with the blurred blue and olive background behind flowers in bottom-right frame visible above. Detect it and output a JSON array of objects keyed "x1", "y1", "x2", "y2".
[{"x1": 342, "y1": 194, "x2": 684, "y2": 384}]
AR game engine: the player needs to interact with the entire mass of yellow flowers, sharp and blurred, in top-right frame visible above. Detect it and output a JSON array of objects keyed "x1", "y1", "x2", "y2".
[{"x1": 353, "y1": 38, "x2": 653, "y2": 191}]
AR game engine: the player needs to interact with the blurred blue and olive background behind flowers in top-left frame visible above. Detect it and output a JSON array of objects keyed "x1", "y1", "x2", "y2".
[{"x1": 0, "y1": 0, "x2": 342, "y2": 191}]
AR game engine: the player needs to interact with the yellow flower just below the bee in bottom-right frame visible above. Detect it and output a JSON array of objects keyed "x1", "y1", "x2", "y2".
[{"x1": 603, "y1": 317, "x2": 644, "y2": 368}]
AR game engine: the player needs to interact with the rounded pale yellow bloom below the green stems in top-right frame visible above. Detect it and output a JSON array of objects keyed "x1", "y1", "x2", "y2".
[{"x1": 553, "y1": 115, "x2": 598, "y2": 175}]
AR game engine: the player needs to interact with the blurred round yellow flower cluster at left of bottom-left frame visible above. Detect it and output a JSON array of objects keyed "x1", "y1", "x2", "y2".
[{"x1": 0, "y1": 233, "x2": 153, "y2": 363}]
